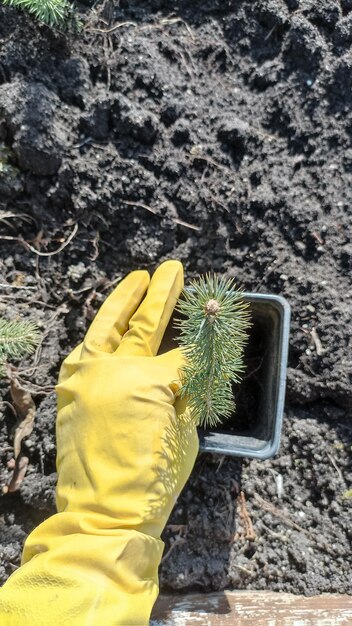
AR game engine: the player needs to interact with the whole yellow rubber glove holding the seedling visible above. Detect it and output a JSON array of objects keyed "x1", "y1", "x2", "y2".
[{"x1": 0, "y1": 261, "x2": 198, "y2": 626}]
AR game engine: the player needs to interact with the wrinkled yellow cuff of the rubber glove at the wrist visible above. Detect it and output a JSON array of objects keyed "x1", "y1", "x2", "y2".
[{"x1": 0, "y1": 513, "x2": 163, "y2": 626}]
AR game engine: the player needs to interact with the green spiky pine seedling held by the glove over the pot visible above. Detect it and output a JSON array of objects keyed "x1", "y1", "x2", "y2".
[{"x1": 176, "y1": 274, "x2": 250, "y2": 427}]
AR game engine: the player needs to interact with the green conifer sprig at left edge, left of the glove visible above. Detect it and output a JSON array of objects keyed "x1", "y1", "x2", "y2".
[{"x1": 0, "y1": 318, "x2": 40, "y2": 376}]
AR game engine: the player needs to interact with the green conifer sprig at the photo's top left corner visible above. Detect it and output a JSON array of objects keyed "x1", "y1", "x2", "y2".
[{"x1": 0, "y1": 0, "x2": 72, "y2": 27}]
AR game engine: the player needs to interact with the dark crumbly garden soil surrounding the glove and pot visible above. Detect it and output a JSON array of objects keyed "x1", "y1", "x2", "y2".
[{"x1": 0, "y1": 0, "x2": 352, "y2": 594}]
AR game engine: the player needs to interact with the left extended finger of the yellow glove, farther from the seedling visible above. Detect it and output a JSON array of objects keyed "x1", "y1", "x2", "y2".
[{"x1": 81, "y1": 270, "x2": 150, "y2": 358}]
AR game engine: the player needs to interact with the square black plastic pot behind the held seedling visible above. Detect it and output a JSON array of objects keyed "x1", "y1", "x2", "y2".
[{"x1": 199, "y1": 293, "x2": 290, "y2": 459}]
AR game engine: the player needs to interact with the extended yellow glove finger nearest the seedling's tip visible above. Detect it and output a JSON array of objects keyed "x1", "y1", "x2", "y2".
[{"x1": 116, "y1": 261, "x2": 183, "y2": 356}]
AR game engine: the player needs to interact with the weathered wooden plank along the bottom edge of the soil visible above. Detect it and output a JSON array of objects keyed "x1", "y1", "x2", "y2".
[{"x1": 150, "y1": 591, "x2": 352, "y2": 626}]
